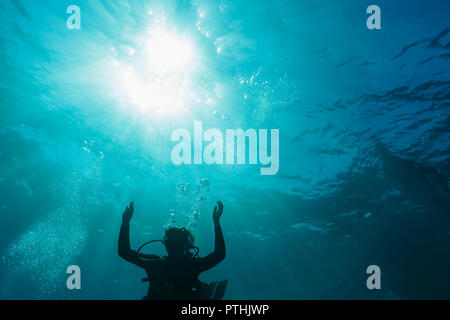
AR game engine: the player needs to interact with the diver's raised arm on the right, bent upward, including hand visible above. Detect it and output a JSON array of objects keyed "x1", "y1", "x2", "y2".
[{"x1": 198, "y1": 201, "x2": 225, "y2": 271}]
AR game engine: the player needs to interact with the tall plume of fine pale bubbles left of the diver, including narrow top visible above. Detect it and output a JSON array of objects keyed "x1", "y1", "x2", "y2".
[{"x1": 2, "y1": 167, "x2": 93, "y2": 299}]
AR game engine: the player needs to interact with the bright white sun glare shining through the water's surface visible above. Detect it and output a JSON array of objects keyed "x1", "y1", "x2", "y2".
[{"x1": 120, "y1": 26, "x2": 195, "y2": 115}]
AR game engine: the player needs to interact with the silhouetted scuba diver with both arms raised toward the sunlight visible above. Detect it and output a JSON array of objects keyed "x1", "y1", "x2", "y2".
[{"x1": 119, "y1": 201, "x2": 228, "y2": 300}]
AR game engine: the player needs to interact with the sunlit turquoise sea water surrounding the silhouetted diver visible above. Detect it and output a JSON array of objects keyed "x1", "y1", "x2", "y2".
[{"x1": 0, "y1": 0, "x2": 450, "y2": 299}]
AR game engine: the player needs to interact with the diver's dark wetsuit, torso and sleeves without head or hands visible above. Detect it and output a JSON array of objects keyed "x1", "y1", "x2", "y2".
[{"x1": 119, "y1": 222, "x2": 225, "y2": 300}]
